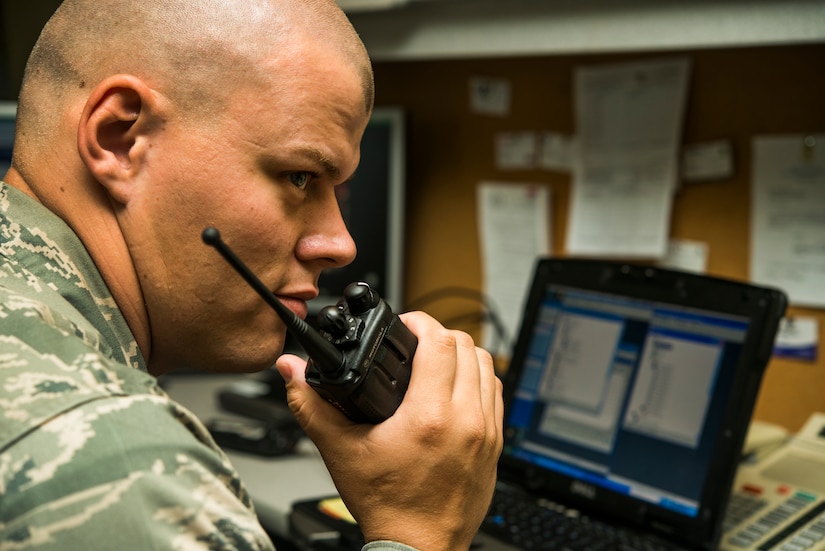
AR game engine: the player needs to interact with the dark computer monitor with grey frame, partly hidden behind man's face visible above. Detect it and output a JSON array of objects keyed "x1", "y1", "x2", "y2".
[{"x1": 309, "y1": 107, "x2": 405, "y2": 314}]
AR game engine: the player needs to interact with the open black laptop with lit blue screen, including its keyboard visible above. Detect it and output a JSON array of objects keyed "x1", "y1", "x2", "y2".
[{"x1": 474, "y1": 258, "x2": 786, "y2": 551}]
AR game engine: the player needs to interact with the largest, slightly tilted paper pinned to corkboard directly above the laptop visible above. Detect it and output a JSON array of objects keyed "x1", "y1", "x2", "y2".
[{"x1": 566, "y1": 58, "x2": 690, "y2": 258}]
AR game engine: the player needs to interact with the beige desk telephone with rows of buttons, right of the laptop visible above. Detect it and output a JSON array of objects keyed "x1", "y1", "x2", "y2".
[{"x1": 720, "y1": 413, "x2": 825, "y2": 551}]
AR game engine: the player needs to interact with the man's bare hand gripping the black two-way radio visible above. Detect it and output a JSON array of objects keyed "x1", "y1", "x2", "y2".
[{"x1": 277, "y1": 312, "x2": 504, "y2": 551}]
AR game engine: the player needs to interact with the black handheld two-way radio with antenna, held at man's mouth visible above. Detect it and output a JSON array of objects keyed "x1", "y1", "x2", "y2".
[{"x1": 202, "y1": 227, "x2": 418, "y2": 423}]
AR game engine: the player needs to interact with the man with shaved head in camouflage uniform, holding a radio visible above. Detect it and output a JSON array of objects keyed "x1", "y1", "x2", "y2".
[{"x1": 0, "y1": 0, "x2": 503, "y2": 551}]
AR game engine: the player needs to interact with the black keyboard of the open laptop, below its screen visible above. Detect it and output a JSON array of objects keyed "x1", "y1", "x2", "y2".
[{"x1": 482, "y1": 488, "x2": 681, "y2": 551}]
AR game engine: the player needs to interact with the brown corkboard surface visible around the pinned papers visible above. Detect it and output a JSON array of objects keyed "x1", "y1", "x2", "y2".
[{"x1": 375, "y1": 44, "x2": 825, "y2": 430}]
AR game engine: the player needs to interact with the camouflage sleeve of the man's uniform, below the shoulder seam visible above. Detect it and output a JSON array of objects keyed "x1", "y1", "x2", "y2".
[{"x1": 0, "y1": 395, "x2": 273, "y2": 551}]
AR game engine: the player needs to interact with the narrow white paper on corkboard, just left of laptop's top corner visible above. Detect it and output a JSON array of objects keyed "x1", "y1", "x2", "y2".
[{"x1": 477, "y1": 182, "x2": 551, "y2": 355}]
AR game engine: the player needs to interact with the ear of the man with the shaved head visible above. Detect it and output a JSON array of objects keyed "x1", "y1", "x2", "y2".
[{"x1": 77, "y1": 75, "x2": 158, "y2": 204}]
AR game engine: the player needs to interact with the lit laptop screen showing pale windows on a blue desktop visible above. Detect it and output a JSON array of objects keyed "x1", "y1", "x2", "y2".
[{"x1": 505, "y1": 284, "x2": 748, "y2": 517}]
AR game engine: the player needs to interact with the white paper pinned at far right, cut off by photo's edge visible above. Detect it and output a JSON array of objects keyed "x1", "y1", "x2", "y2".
[{"x1": 750, "y1": 135, "x2": 825, "y2": 307}]
